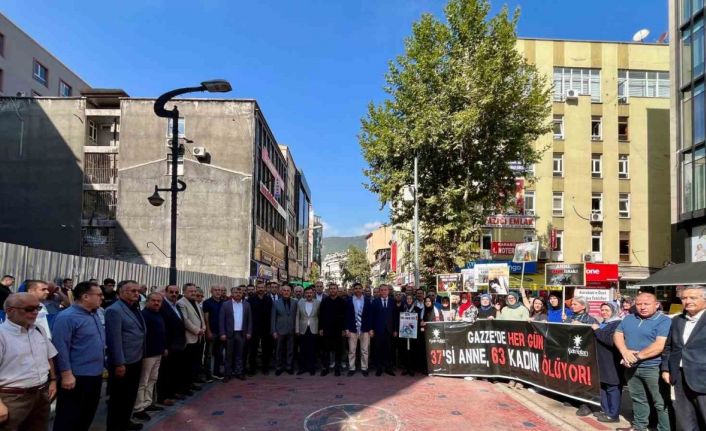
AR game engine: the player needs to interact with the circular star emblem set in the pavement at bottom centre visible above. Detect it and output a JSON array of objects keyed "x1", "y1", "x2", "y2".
[{"x1": 304, "y1": 404, "x2": 401, "y2": 431}]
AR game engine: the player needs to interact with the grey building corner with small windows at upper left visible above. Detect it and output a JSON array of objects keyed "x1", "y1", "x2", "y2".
[{"x1": 0, "y1": 13, "x2": 90, "y2": 97}]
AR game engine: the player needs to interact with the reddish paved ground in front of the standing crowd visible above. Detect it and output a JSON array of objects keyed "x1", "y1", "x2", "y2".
[{"x1": 81, "y1": 374, "x2": 627, "y2": 431}]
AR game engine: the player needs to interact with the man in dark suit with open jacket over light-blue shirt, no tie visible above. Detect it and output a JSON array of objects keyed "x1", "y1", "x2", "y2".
[{"x1": 218, "y1": 287, "x2": 252, "y2": 383}]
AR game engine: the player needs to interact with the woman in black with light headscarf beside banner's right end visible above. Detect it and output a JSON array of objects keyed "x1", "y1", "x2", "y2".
[{"x1": 593, "y1": 302, "x2": 623, "y2": 422}]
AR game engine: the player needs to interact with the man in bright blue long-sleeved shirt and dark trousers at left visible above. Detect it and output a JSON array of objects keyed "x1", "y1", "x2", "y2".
[{"x1": 52, "y1": 281, "x2": 105, "y2": 431}]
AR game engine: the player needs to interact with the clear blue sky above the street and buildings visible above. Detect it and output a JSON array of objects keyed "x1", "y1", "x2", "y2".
[{"x1": 0, "y1": 0, "x2": 668, "y2": 236}]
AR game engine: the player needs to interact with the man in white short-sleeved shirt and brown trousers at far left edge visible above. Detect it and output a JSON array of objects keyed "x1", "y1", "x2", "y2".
[{"x1": 0, "y1": 293, "x2": 57, "y2": 430}]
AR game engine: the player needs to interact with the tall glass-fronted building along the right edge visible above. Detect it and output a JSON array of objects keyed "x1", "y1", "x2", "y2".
[{"x1": 669, "y1": 0, "x2": 706, "y2": 263}]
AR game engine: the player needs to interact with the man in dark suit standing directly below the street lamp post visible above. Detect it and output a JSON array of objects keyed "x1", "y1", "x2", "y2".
[{"x1": 157, "y1": 285, "x2": 189, "y2": 406}]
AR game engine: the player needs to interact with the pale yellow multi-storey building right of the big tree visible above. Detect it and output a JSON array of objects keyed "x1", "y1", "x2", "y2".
[{"x1": 480, "y1": 39, "x2": 670, "y2": 286}]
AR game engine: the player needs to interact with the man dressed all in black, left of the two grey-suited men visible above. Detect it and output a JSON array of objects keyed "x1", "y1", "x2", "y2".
[{"x1": 247, "y1": 281, "x2": 274, "y2": 376}]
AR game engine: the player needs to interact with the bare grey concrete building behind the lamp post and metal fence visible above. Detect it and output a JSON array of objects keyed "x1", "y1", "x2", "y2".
[{"x1": 0, "y1": 90, "x2": 310, "y2": 281}]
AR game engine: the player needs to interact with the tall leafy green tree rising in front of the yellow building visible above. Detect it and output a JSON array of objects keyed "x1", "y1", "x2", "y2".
[{"x1": 359, "y1": 0, "x2": 551, "y2": 273}]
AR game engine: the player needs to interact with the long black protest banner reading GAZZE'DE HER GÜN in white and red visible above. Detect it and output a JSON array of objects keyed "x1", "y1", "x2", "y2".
[{"x1": 425, "y1": 320, "x2": 600, "y2": 404}]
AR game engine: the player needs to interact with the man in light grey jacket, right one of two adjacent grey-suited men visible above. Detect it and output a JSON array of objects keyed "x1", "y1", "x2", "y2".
[{"x1": 295, "y1": 286, "x2": 320, "y2": 376}]
